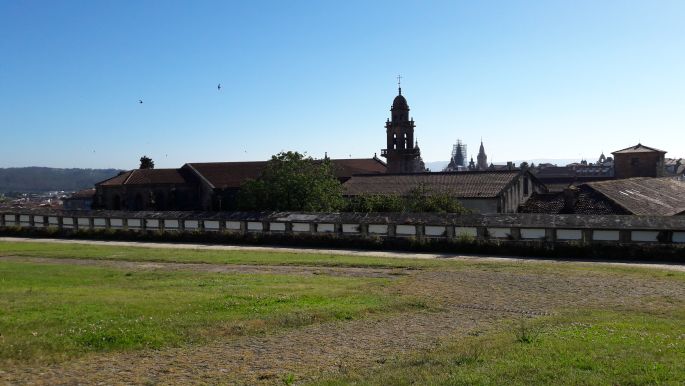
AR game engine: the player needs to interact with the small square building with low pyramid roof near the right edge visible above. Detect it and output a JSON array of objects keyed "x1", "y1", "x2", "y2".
[{"x1": 611, "y1": 143, "x2": 666, "y2": 179}]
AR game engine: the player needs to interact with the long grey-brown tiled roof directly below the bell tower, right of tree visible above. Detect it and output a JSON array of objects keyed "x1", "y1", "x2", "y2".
[{"x1": 343, "y1": 171, "x2": 521, "y2": 198}]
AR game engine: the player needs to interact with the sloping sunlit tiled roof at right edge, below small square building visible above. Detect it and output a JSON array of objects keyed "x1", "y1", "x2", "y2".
[{"x1": 585, "y1": 177, "x2": 685, "y2": 216}]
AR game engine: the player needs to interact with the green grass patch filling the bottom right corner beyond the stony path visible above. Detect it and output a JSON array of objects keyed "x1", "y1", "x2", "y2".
[{"x1": 316, "y1": 309, "x2": 685, "y2": 386}]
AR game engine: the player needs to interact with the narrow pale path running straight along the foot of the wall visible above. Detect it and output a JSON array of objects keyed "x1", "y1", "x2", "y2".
[{"x1": 0, "y1": 237, "x2": 685, "y2": 272}]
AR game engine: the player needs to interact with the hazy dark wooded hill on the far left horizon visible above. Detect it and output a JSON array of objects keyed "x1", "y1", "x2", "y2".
[{"x1": 0, "y1": 167, "x2": 120, "y2": 193}]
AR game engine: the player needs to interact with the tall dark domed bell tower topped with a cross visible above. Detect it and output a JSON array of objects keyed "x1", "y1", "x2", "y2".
[{"x1": 381, "y1": 76, "x2": 425, "y2": 173}]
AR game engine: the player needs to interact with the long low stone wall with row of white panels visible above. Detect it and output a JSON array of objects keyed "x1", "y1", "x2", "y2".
[{"x1": 0, "y1": 210, "x2": 685, "y2": 244}]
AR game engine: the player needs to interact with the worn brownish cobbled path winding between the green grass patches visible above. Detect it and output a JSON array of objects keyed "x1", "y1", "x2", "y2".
[{"x1": 5, "y1": 255, "x2": 685, "y2": 384}]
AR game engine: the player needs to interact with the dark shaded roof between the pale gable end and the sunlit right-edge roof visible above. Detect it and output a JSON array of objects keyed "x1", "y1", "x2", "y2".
[{"x1": 519, "y1": 187, "x2": 630, "y2": 215}]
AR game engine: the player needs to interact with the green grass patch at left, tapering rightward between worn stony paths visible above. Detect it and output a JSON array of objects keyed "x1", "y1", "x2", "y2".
[{"x1": 0, "y1": 261, "x2": 412, "y2": 363}]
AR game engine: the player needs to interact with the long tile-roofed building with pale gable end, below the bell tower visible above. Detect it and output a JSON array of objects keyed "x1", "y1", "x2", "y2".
[{"x1": 343, "y1": 170, "x2": 547, "y2": 214}]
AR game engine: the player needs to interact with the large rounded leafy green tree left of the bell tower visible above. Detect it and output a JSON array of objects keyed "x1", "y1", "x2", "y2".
[{"x1": 237, "y1": 151, "x2": 344, "y2": 212}]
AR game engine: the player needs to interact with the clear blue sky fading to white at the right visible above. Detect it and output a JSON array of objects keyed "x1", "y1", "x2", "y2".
[{"x1": 0, "y1": 0, "x2": 685, "y2": 168}]
